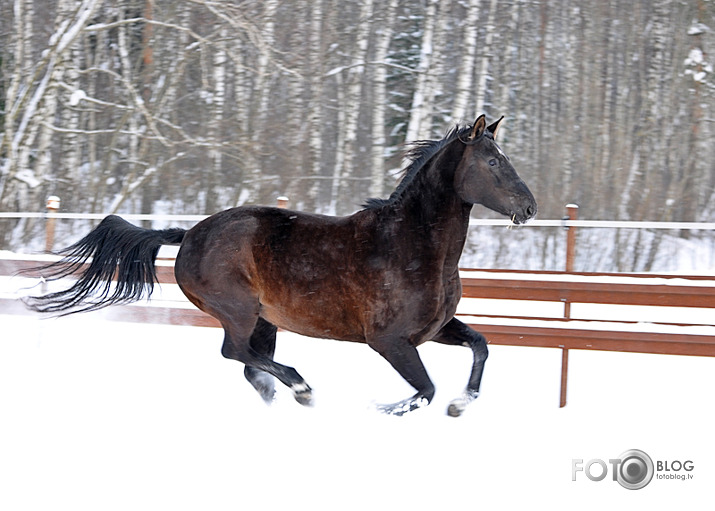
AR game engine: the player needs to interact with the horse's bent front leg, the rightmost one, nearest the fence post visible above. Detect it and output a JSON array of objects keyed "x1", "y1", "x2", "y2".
[{"x1": 433, "y1": 318, "x2": 489, "y2": 417}]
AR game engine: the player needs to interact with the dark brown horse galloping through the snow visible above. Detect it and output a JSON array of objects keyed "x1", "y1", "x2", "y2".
[{"x1": 28, "y1": 115, "x2": 536, "y2": 416}]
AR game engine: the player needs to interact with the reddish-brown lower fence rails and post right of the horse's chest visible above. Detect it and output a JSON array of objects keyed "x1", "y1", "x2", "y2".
[{"x1": 461, "y1": 270, "x2": 715, "y2": 406}]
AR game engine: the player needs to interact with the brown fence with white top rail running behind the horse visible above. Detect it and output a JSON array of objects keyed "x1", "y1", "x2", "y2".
[{"x1": 0, "y1": 205, "x2": 715, "y2": 406}]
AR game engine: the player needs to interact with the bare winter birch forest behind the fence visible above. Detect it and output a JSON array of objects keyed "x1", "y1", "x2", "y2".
[{"x1": 0, "y1": 0, "x2": 715, "y2": 270}]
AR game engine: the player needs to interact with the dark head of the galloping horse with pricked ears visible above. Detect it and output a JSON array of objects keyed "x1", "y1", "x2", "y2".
[{"x1": 454, "y1": 115, "x2": 536, "y2": 224}]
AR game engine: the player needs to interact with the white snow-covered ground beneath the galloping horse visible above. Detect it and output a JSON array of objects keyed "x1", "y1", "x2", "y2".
[{"x1": 0, "y1": 311, "x2": 715, "y2": 511}]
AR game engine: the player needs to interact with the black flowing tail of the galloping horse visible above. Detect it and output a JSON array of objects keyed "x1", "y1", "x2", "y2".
[{"x1": 25, "y1": 215, "x2": 186, "y2": 315}]
